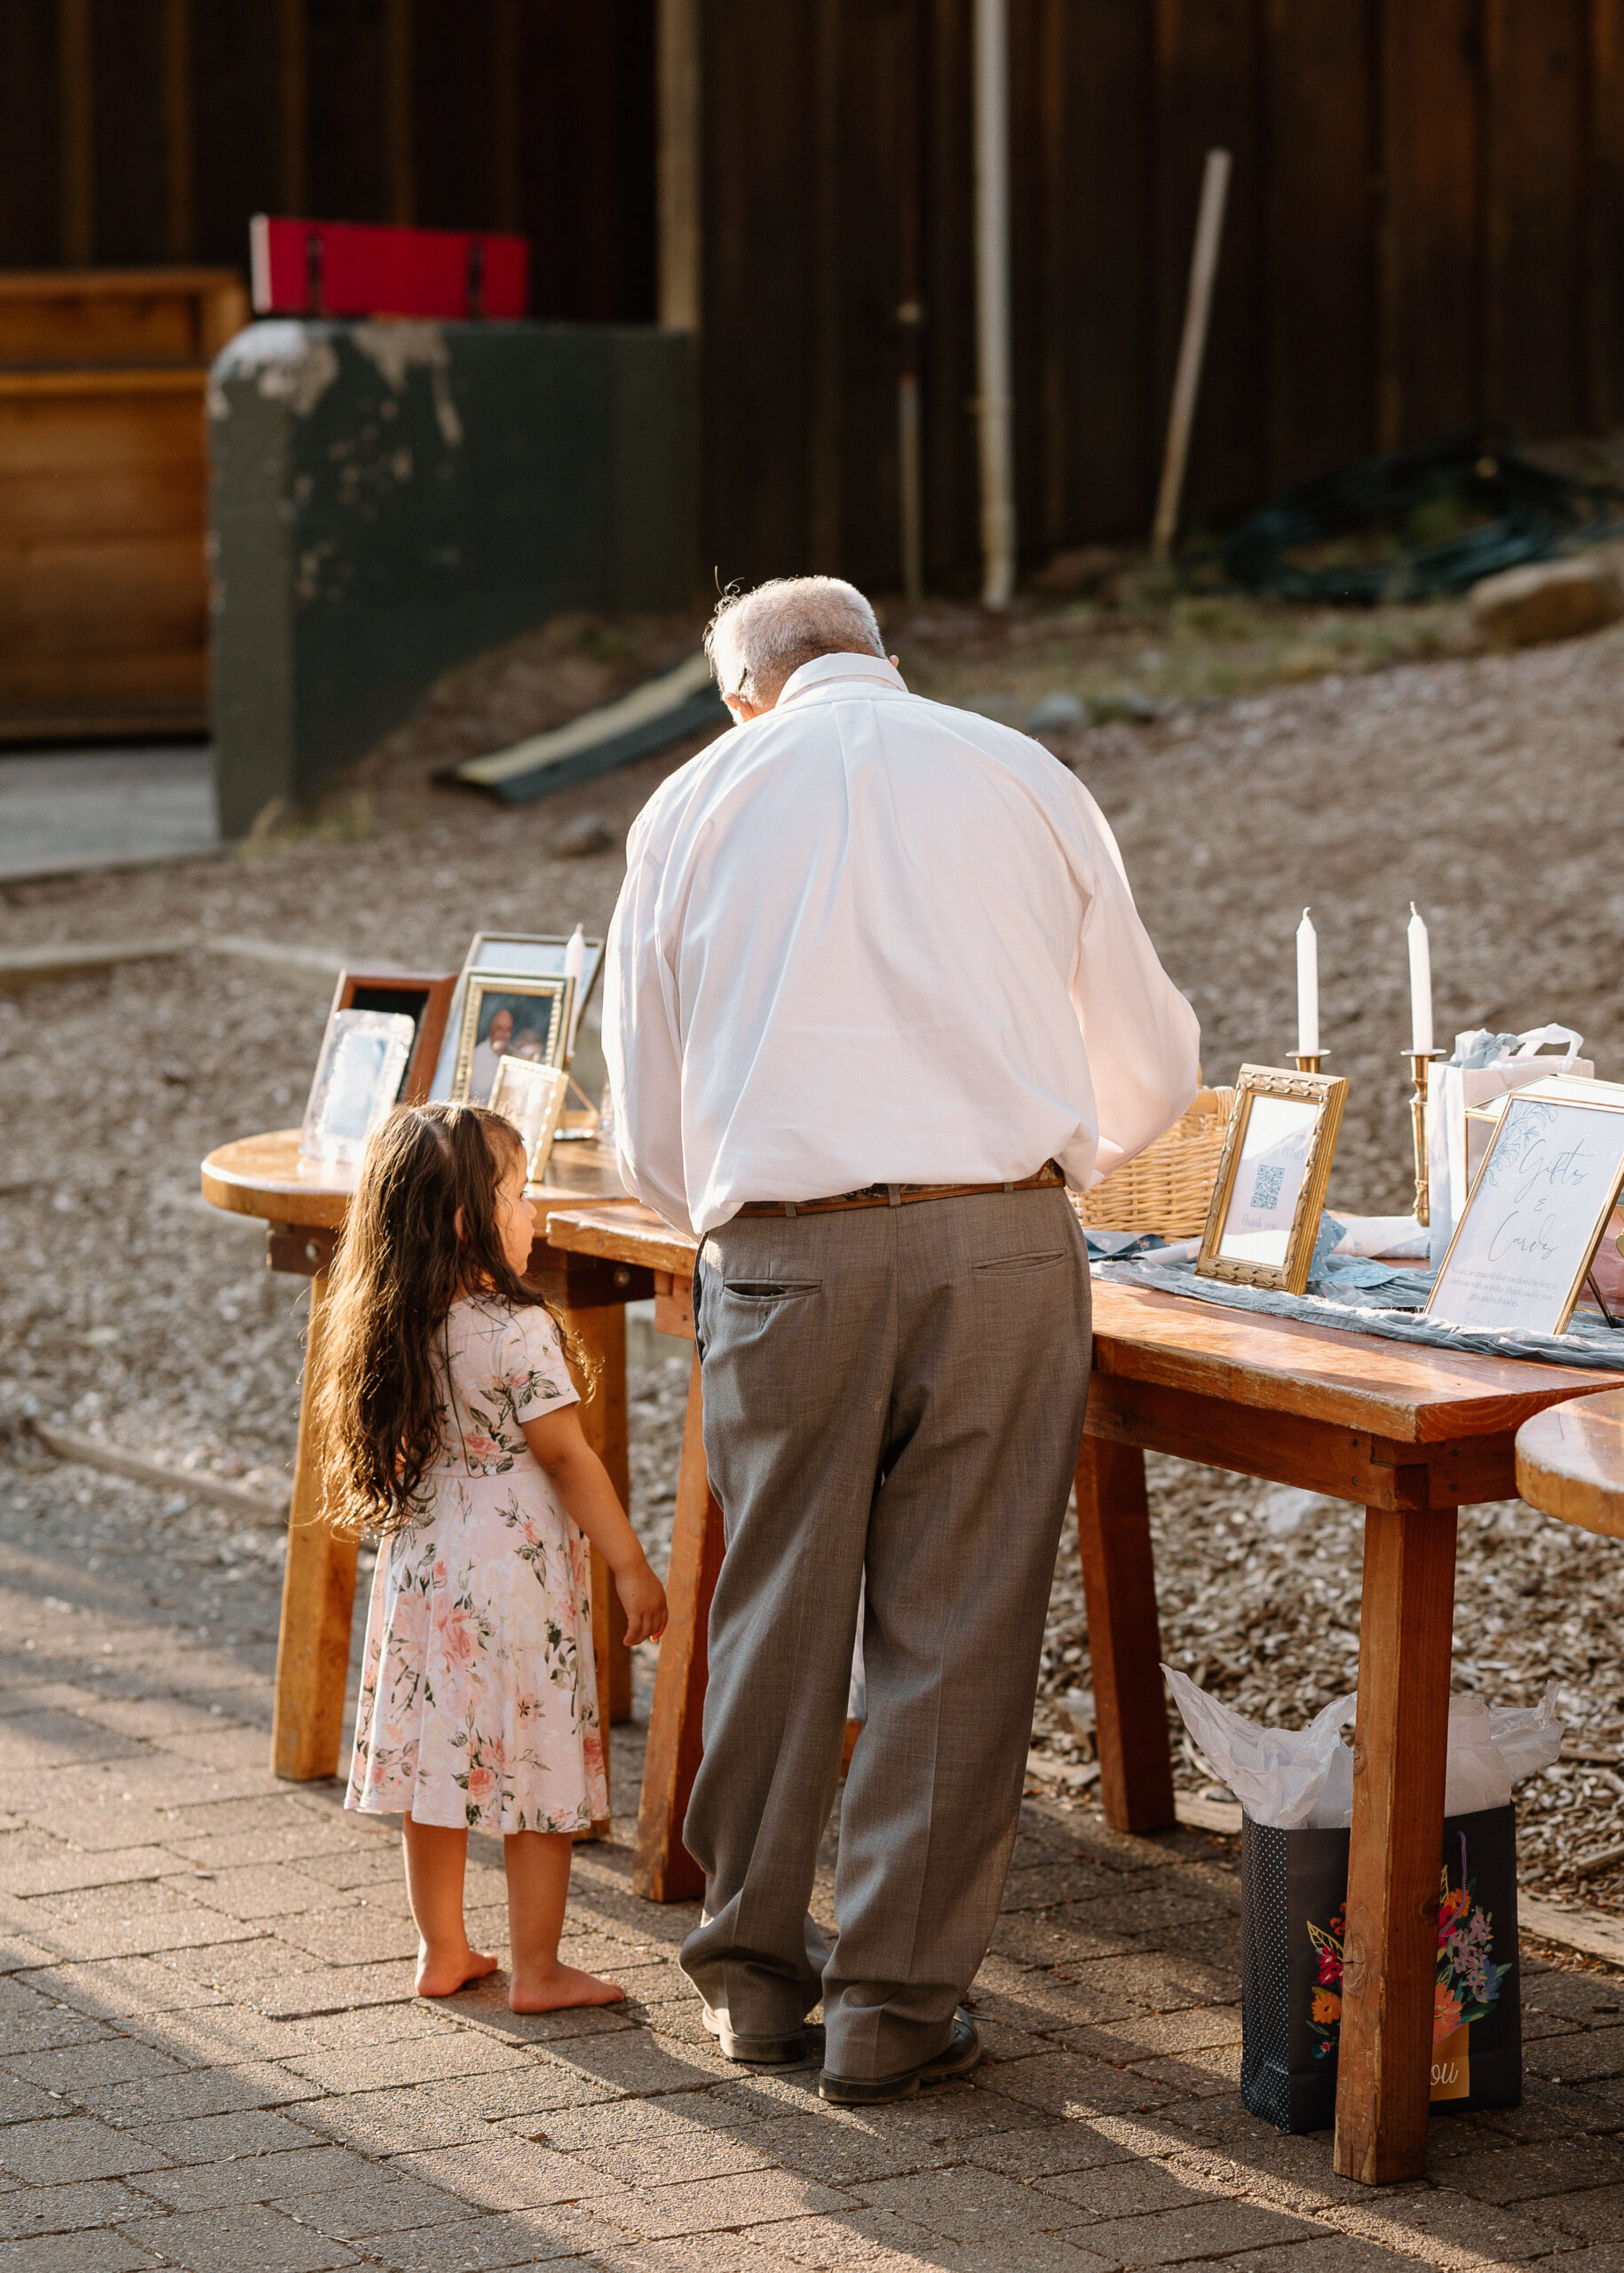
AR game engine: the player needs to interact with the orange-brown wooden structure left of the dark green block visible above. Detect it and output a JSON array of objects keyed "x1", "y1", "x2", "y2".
[{"x1": 0, "y1": 268, "x2": 248, "y2": 743}]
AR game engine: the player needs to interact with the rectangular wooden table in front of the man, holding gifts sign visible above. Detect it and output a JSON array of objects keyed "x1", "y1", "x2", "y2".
[{"x1": 548, "y1": 1207, "x2": 1624, "y2": 2184}]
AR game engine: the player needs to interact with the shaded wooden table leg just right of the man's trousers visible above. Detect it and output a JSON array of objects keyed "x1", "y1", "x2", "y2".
[{"x1": 1076, "y1": 1437, "x2": 1174, "y2": 1832}]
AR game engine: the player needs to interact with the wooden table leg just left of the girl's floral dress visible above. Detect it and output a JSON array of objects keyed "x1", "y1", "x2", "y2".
[{"x1": 271, "y1": 1271, "x2": 360, "y2": 1782}]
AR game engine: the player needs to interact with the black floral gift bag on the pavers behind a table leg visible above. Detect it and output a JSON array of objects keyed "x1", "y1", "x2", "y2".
[{"x1": 1240, "y1": 1802, "x2": 1522, "y2": 2132}]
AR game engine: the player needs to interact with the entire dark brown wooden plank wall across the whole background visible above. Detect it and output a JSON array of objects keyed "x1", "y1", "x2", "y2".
[{"x1": 0, "y1": 0, "x2": 1624, "y2": 586}]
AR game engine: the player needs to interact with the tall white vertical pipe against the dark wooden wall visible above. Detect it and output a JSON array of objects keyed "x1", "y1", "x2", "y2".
[{"x1": 976, "y1": 0, "x2": 1014, "y2": 607}]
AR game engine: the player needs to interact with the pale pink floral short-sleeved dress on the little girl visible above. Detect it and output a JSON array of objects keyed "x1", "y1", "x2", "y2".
[{"x1": 345, "y1": 1295, "x2": 610, "y2": 1832}]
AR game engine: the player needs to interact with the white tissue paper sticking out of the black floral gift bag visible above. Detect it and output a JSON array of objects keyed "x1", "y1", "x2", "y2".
[{"x1": 1162, "y1": 1666, "x2": 1563, "y2": 1830}]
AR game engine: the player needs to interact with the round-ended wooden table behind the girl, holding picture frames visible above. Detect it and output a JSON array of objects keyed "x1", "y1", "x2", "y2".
[{"x1": 202, "y1": 1129, "x2": 637, "y2": 1818}]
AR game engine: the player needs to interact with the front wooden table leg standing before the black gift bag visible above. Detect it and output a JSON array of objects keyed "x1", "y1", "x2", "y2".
[{"x1": 1335, "y1": 1507, "x2": 1455, "y2": 2187}]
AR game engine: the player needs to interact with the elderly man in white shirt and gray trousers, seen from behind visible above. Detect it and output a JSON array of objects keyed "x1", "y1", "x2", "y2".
[{"x1": 605, "y1": 577, "x2": 1196, "y2": 2105}]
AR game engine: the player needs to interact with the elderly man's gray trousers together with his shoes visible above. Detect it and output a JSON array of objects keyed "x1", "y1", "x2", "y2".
[{"x1": 682, "y1": 1189, "x2": 1089, "y2": 2078}]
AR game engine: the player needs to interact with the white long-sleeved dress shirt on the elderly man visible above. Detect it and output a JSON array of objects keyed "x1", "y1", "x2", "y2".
[{"x1": 603, "y1": 654, "x2": 1199, "y2": 1237}]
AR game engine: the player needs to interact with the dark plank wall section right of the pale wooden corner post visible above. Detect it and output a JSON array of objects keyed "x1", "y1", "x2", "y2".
[{"x1": 703, "y1": 0, "x2": 1624, "y2": 582}]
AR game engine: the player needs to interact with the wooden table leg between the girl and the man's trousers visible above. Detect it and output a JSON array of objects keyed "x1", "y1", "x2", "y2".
[{"x1": 632, "y1": 1352, "x2": 724, "y2": 1903}]
